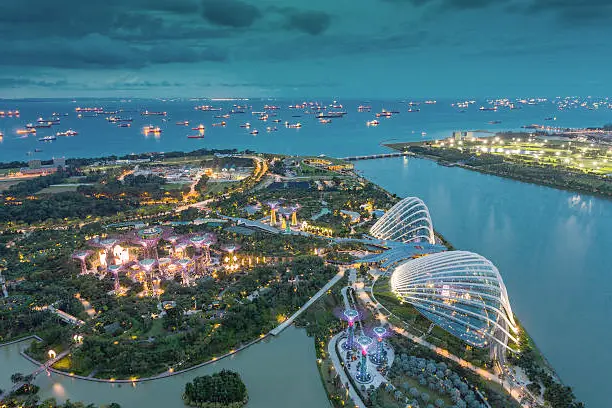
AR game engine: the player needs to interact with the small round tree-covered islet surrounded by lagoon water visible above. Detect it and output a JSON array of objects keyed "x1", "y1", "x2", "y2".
[{"x1": 183, "y1": 370, "x2": 248, "y2": 408}]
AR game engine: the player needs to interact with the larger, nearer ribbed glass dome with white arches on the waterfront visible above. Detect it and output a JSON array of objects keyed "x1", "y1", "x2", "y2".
[{"x1": 391, "y1": 251, "x2": 518, "y2": 348}]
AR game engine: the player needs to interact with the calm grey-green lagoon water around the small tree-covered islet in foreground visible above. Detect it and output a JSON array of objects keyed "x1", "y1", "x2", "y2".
[{"x1": 0, "y1": 326, "x2": 330, "y2": 408}]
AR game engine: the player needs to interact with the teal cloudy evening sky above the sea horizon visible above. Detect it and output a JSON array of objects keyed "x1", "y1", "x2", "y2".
[{"x1": 0, "y1": 0, "x2": 612, "y2": 98}]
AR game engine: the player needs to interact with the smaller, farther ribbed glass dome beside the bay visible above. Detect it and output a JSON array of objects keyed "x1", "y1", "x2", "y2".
[{"x1": 370, "y1": 197, "x2": 435, "y2": 244}]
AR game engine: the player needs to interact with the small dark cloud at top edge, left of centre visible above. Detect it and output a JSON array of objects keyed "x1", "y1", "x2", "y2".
[{"x1": 202, "y1": 0, "x2": 261, "y2": 28}]
